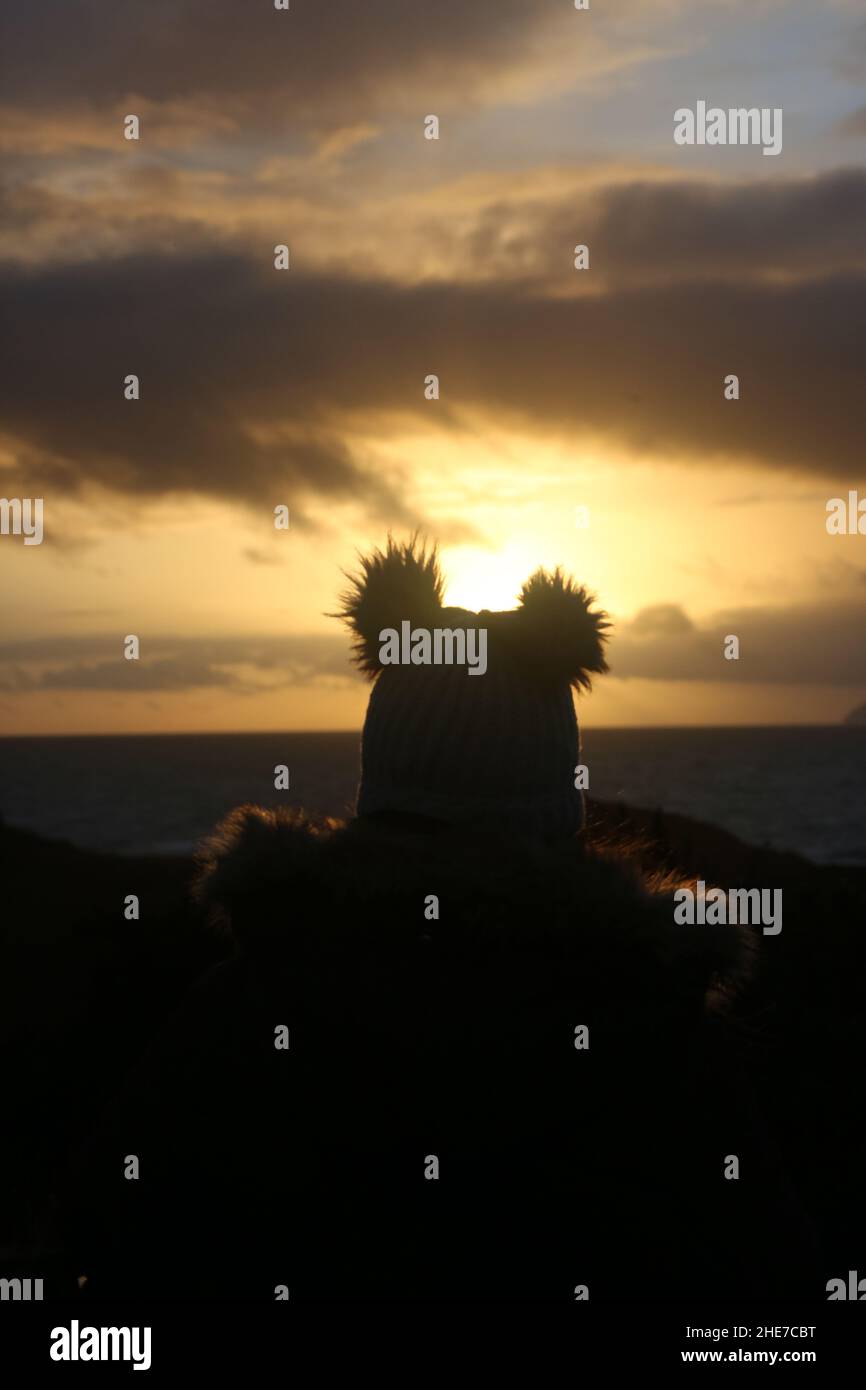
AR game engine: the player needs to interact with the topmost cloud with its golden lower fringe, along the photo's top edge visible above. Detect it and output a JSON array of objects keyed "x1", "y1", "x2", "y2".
[{"x1": 0, "y1": 0, "x2": 790, "y2": 154}]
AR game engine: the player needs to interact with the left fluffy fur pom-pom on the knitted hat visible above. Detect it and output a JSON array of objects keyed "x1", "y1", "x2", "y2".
[{"x1": 327, "y1": 531, "x2": 445, "y2": 677}]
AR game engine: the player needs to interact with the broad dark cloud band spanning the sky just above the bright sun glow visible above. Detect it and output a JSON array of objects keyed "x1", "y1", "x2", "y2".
[{"x1": 0, "y1": 247, "x2": 866, "y2": 511}]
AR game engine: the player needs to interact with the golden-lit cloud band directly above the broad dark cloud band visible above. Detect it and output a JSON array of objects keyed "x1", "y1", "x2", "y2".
[{"x1": 6, "y1": 159, "x2": 866, "y2": 287}]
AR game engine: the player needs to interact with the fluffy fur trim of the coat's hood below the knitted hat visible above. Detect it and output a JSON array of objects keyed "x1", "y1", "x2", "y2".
[{"x1": 196, "y1": 806, "x2": 755, "y2": 1011}]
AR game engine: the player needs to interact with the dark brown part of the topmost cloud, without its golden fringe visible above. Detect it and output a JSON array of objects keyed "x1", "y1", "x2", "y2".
[{"x1": 1, "y1": 0, "x2": 567, "y2": 126}]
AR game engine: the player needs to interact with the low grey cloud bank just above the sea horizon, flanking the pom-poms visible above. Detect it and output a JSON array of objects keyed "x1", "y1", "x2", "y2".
[{"x1": 6, "y1": 594, "x2": 866, "y2": 695}]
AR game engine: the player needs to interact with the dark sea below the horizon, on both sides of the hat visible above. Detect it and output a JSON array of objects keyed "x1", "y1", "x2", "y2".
[{"x1": 0, "y1": 726, "x2": 866, "y2": 865}]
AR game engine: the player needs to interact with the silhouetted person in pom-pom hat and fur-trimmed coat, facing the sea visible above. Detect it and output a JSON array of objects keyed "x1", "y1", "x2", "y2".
[{"x1": 64, "y1": 542, "x2": 805, "y2": 1301}]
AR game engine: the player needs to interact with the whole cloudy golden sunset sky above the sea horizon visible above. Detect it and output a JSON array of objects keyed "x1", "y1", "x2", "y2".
[{"x1": 0, "y1": 0, "x2": 866, "y2": 734}]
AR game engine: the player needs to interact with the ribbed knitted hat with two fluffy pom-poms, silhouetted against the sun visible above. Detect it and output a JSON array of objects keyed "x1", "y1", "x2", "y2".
[{"x1": 332, "y1": 535, "x2": 609, "y2": 838}]
